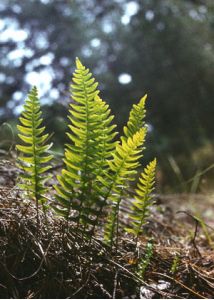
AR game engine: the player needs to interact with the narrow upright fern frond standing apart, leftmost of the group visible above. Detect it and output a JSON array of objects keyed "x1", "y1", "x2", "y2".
[{"x1": 16, "y1": 87, "x2": 52, "y2": 217}]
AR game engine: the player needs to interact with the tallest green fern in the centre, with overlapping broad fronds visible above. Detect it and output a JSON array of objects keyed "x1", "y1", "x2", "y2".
[{"x1": 55, "y1": 59, "x2": 116, "y2": 226}]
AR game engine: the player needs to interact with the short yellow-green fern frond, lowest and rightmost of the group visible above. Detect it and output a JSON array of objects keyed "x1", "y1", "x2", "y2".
[{"x1": 126, "y1": 159, "x2": 156, "y2": 240}]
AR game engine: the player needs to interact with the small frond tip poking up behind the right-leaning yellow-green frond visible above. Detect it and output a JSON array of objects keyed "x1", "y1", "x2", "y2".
[{"x1": 122, "y1": 95, "x2": 147, "y2": 139}]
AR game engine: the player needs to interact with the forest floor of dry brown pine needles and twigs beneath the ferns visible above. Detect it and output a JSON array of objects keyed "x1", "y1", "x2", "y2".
[{"x1": 0, "y1": 161, "x2": 214, "y2": 299}]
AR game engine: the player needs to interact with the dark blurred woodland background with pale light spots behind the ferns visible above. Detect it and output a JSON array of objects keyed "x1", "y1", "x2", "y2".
[{"x1": 0, "y1": 0, "x2": 214, "y2": 192}]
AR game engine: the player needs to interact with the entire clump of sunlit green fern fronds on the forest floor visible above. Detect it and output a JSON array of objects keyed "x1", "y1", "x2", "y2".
[{"x1": 17, "y1": 59, "x2": 156, "y2": 247}]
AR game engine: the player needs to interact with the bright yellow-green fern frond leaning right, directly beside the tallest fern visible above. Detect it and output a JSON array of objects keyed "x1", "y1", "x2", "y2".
[{"x1": 102, "y1": 128, "x2": 146, "y2": 245}]
